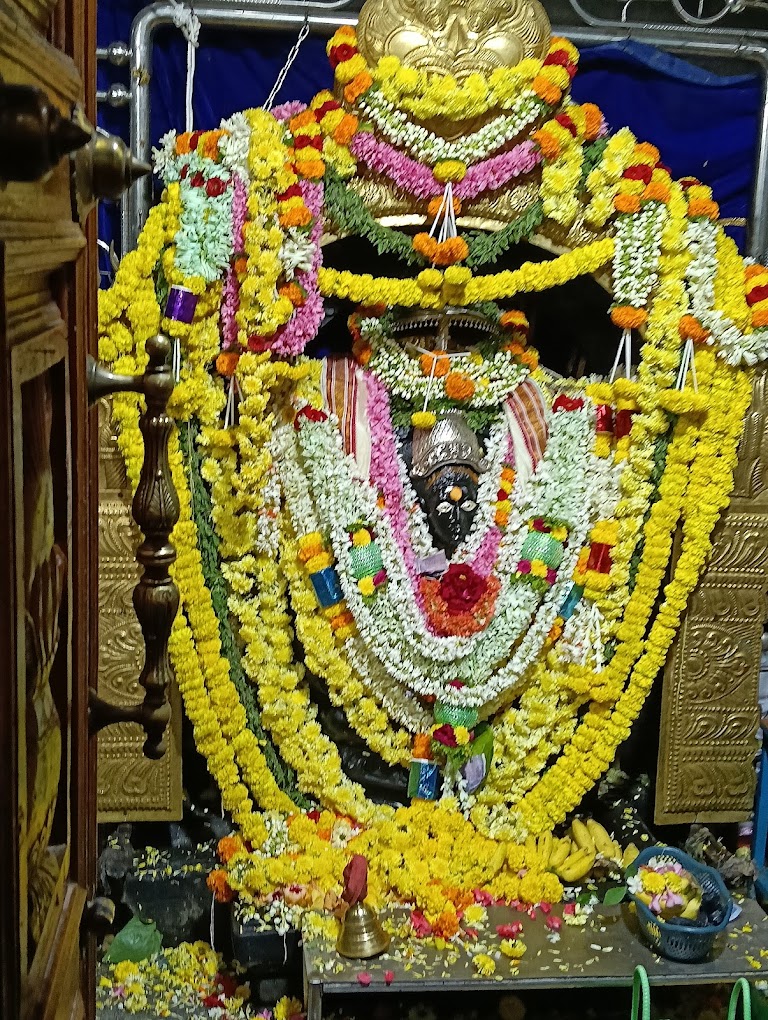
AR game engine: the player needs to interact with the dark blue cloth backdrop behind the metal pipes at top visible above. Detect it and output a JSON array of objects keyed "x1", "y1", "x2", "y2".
[{"x1": 98, "y1": 0, "x2": 762, "y2": 279}]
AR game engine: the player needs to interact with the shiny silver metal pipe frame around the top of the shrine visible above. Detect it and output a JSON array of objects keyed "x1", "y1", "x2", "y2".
[{"x1": 121, "y1": 0, "x2": 768, "y2": 259}]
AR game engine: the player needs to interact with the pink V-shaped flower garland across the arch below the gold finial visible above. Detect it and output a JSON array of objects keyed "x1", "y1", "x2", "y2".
[{"x1": 350, "y1": 132, "x2": 542, "y2": 200}]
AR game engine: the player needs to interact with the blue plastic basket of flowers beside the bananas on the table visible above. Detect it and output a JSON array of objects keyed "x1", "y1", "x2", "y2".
[{"x1": 626, "y1": 847, "x2": 733, "y2": 963}]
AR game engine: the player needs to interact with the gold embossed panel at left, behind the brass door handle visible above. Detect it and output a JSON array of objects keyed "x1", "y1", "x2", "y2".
[{"x1": 93, "y1": 402, "x2": 182, "y2": 822}]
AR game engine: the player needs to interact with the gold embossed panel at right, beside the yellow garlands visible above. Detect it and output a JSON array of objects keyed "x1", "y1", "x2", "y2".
[{"x1": 656, "y1": 369, "x2": 768, "y2": 824}]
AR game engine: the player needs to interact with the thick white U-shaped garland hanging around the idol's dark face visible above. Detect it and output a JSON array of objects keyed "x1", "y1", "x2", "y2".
[{"x1": 288, "y1": 397, "x2": 595, "y2": 706}]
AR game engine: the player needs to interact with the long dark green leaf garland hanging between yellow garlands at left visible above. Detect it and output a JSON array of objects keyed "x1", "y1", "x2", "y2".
[{"x1": 178, "y1": 419, "x2": 311, "y2": 809}]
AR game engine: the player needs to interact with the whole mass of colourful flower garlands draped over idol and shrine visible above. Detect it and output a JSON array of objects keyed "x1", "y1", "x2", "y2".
[{"x1": 99, "y1": 1, "x2": 768, "y2": 938}]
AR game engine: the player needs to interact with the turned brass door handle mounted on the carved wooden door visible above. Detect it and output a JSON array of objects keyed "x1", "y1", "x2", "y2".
[{"x1": 89, "y1": 335, "x2": 178, "y2": 759}]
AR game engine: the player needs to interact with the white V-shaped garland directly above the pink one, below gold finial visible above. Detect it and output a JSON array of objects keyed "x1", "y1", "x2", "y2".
[{"x1": 358, "y1": 89, "x2": 545, "y2": 165}]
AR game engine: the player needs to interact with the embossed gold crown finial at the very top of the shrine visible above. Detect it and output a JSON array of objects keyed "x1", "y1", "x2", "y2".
[{"x1": 357, "y1": 0, "x2": 552, "y2": 81}]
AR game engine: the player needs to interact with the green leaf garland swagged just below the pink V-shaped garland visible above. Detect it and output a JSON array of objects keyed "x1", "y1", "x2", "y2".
[{"x1": 324, "y1": 167, "x2": 544, "y2": 268}]
